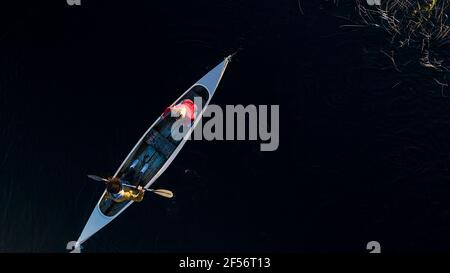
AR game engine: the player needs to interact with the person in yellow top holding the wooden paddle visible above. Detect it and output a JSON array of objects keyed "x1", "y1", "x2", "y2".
[{"x1": 106, "y1": 177, "x2": 145, "y2": 203}]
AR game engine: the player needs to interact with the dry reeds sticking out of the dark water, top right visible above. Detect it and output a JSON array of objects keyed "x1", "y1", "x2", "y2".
[{"x1": 356, "y1": 0, "x2": 450, "y2": 72}]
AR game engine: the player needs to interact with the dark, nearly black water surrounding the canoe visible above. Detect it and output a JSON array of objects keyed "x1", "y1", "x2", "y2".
[{"x1": 0, "y1": 0, "x2": 450, "y2": 252}]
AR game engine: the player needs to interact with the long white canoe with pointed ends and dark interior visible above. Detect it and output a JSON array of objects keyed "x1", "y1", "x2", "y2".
[{"x1": 74, "y1": 56, "x2": 231, "y2": 249}]
